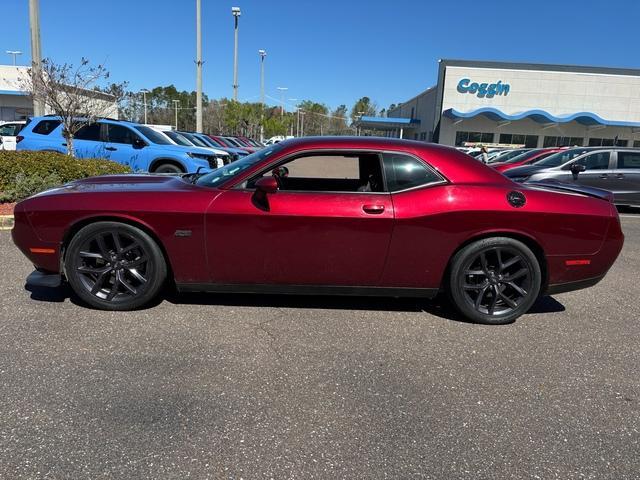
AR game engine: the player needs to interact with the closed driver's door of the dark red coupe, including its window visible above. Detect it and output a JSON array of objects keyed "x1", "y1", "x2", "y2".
[{"x1": 206, "y1": 151, "x2": 393, "y2": 286}]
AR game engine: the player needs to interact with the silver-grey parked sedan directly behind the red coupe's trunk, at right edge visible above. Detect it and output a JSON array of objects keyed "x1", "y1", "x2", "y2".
[{"x1": 504, "y1": 147, "x2": 640, "y2": 206}]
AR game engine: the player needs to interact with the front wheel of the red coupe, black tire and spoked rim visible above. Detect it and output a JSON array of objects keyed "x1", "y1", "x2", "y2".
[{"x1": 64, "y1": 222, "x2": 167, "y2": 310}]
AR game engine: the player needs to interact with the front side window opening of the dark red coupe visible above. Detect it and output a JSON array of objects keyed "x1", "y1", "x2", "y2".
[{"x1": 247, "y1": 152, "x2": 384, "y2": 192}]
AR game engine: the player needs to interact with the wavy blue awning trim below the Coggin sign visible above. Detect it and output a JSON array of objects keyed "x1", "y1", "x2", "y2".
[{"x1": 442, "y1": 107, "x2": 640, "y2": 127}]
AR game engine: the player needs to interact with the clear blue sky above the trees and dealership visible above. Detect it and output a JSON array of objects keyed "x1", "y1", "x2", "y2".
[{"x1": 0, "y1": 0, "x2": 640, "y2": 111}]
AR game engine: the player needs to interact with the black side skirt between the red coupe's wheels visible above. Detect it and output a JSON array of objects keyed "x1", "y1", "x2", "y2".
[{"x1": 176, "y1": 283, "x2": 438, "y2": 298}]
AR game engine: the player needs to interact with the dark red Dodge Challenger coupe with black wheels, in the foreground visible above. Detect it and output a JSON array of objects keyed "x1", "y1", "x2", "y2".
[{"x1": 13, "y1": 137, "x2": 623, "y2": 324}]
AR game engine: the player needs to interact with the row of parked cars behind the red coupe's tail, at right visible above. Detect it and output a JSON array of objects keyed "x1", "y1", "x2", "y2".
[{"x1": 470, "y1": 147, "x2": 640, "y2": 206}]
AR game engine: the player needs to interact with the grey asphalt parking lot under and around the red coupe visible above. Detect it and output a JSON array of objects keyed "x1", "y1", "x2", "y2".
[{"x1": 0, "y1": 214, "x2": 640, "y2": 479}]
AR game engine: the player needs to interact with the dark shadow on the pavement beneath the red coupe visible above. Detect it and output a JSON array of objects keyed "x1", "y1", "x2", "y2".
[{"x1": 25, "y1": 284, "x2": 565, "y2": 323}]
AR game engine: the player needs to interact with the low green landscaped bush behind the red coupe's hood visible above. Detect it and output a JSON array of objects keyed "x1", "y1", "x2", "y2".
[{"x1": 0, "y1": 151, "x2": 131, "y2": 202}]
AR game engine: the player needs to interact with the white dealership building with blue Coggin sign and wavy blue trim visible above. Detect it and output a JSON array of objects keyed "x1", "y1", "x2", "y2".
[{"x1": 382, "y1": 60, "x2": 640, "y2": 147}]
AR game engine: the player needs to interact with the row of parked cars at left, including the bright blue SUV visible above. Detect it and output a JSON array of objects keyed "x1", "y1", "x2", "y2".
[{"x1": 0, "y1": 116, "x2": 263, "y2": 173}]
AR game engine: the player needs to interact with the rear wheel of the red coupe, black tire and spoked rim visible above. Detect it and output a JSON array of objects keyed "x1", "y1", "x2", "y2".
[{"x1": 447, "y1": 237, "x2": 542, "y2": 325}]
